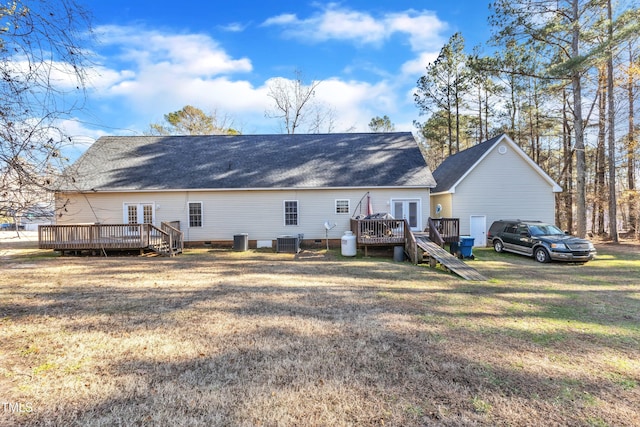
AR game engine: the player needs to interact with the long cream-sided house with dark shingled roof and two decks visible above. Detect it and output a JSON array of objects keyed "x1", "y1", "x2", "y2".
[{"x1": 56, "y1": 133, "x2": 435, "y2": 246}]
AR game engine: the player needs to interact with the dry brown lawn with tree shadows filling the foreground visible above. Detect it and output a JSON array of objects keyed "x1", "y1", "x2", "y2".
[{"x1": 0, "y1": 236, "x2": 640, "y2": 426}]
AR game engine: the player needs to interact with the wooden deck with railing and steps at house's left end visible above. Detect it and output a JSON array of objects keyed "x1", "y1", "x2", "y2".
[{"x1": 38, "y1": 223, "x2": 184, "y2": 256}]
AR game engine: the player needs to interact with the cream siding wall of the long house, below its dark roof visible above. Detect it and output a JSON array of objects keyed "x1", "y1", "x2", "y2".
[{"x1": 56, "y1": 188, "x2": 430, "y2": 242}]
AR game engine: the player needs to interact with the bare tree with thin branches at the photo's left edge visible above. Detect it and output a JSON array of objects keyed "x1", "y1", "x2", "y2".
[{"x1": 0, "y1": 0, "x2": 91, "y2": 227}]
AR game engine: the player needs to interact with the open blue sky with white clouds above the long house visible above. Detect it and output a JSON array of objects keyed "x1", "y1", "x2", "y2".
[{"x1": 65, "y1": 0, "x2": 489, "y2": 149}]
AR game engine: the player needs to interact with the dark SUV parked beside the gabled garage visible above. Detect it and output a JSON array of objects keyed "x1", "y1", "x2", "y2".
[{"x1": 487, "y1": 220, "x2": 596, "y2": 262}]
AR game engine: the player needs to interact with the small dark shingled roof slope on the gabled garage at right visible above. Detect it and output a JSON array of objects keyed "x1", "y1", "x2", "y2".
[{"x1": 431, "y1": 134, "x2": 505, "y2": 194}]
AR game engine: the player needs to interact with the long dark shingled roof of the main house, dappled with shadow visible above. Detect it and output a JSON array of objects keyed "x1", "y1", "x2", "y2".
[{"x1": 60, "y1": 132, "x2": 436, "y2": 191}]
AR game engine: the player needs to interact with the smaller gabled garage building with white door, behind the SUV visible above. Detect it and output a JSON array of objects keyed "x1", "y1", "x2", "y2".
[{"x1": 431, "y1": 134, "x2": 562, "y2": 246}]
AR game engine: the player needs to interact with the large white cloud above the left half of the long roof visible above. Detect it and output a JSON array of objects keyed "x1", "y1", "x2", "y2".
[{"x1": 85, "y1": 26, "x2": 267, "y2": 131}]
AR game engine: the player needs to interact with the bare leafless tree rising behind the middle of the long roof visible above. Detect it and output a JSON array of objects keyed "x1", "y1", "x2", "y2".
[{"x1": 265, "y1": 70, "x2": 321, "y2": 134}]
